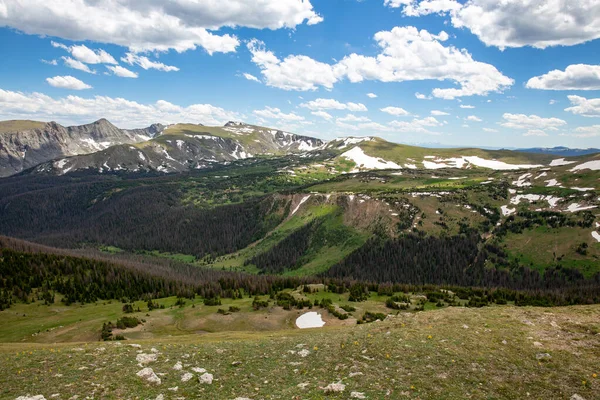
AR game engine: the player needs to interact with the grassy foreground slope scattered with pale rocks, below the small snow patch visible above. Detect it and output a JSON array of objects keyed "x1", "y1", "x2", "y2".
[{"x1": 0, "y1": 305, "x2": 600, "y2": 400}]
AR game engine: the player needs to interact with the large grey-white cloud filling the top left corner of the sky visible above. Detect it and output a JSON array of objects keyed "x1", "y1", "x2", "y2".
[{"x1": 0, "y1": 0, "x2": 323, "y2": 54}]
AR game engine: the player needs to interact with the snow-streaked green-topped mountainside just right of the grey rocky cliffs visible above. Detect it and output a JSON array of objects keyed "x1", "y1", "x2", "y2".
[{"x1": 34, "y1": 122, "x2": 323, "y2": 174}]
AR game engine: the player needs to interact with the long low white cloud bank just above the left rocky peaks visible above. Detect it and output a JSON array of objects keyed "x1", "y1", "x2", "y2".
[{"x1": 0, "y1": 89, "x2": 241, "y2": 128}]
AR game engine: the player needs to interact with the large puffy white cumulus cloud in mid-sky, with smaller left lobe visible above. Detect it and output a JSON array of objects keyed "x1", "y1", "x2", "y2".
[{"x1": 248, "y1": 26, "x2": 514, "y2": 99}]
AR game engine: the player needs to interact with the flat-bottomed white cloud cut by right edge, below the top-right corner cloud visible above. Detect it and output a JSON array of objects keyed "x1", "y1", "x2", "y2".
[{"x1": 525, "y1": 64, "x2": 600, "y2": 90}]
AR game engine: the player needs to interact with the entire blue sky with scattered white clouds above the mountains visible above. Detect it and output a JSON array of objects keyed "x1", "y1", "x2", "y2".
[{"x1": 0, "y1": 0, "x2": 600, "y2": 148}]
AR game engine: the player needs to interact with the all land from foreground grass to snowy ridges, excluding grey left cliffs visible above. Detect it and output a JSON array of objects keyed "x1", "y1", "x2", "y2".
[{"x1": 0, "y1": 122, "x2": 600, "y2": 400}]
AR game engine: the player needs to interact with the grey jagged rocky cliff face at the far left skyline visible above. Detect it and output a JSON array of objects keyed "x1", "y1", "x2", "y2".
[{"x1": 0, "y1": 119, "x2": 164, "y2": 177}]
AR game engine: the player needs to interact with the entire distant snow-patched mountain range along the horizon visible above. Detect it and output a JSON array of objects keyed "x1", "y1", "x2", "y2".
[{"x1": 0, "y1": 119, "x2": 587, "y2": 176}]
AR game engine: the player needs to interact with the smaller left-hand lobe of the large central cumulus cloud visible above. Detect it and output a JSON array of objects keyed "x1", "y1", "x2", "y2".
[{"x1": 248, "y1": 40, "x2": 338, "y2": 91}]
